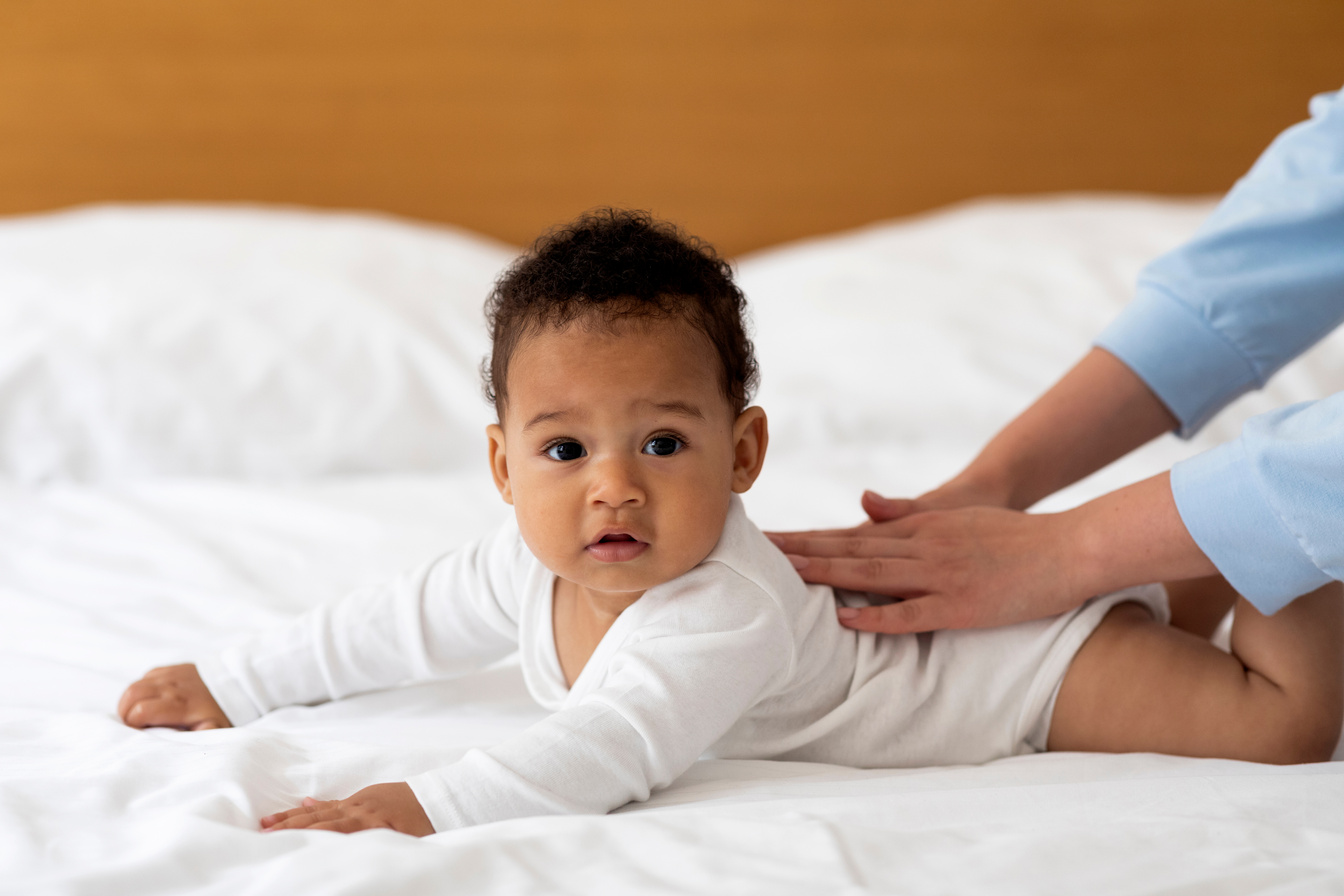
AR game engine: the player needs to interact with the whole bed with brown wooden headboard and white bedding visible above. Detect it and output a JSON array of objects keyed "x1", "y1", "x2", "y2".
[{"x1": 0, "y1": 0, "x2": 1344, "y2": 896}]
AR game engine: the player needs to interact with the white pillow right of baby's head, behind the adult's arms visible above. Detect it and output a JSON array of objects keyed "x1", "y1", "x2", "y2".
[{"x1": 738, "y1": 195, "x2": 1344, "y2": 525}]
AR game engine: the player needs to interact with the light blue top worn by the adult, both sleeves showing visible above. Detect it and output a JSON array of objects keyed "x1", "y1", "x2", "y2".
[{"x1": 1097, "y1": 91, "x2": 1344, "y2": 613}]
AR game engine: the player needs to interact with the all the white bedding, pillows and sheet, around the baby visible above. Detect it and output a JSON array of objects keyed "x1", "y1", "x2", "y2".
[{"x1": 0, "y1": 196, "x2": 1344, "y2": 895}]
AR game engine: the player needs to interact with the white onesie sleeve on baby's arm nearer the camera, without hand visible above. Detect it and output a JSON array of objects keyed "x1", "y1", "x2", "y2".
[{"x1": 407, "y1": 563, "x2": 793, "y2": 832}]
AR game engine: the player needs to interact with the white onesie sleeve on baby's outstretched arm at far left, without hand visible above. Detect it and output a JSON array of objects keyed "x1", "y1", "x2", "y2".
[{"x1": 198, "y1": 527, "x2": 526, "y2": 725}]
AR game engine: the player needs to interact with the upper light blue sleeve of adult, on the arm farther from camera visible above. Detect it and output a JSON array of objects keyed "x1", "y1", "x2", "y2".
[{"x1": 1097, "y1": 91, "x2": 1344, "y2": 435}]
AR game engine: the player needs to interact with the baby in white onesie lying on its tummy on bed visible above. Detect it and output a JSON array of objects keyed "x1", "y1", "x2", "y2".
[{"x1": 118, "y1": 211, "x2": 1344, "y2": 836}]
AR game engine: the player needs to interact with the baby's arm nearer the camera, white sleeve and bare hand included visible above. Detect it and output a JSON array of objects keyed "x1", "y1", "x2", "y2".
[{"x1": 252, "y1": 595, "x2": 792, "y2": 836}]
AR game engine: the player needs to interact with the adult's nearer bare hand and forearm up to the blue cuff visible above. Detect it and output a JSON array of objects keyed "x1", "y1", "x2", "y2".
[{"x1": 770, "y1": 473, "x2": 1218, "y2": 634}]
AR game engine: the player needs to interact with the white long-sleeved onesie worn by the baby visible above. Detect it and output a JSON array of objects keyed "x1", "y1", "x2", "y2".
[{"x1": 198, "y1": 497, "x2": 1167, "y2": 832}]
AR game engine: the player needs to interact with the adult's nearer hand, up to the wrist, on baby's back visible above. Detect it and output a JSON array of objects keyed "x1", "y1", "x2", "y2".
[{"x1": 770, "y1": 496, "x2": 1091, "y2": 634}]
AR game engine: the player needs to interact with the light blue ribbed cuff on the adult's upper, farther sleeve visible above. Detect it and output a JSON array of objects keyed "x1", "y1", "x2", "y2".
[{"x1": 1095, "y1": 282, "x2": 1262, "y2": 438}]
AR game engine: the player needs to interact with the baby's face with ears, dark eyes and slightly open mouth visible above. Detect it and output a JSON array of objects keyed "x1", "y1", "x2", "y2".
[{"x1": 489, "y1": 320, "x2": 766, "y2": 600}]
